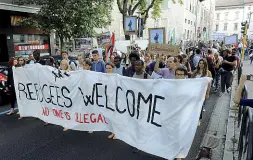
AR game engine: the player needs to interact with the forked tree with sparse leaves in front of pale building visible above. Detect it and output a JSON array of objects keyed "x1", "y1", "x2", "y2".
[{"x1": 117, "y1": 0, "x2": 183, "y2": 40}]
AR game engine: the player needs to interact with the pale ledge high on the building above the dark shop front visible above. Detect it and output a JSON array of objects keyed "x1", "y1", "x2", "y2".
[{"x1": 0, "y1": 2, "x2": 40, "y2": 13}]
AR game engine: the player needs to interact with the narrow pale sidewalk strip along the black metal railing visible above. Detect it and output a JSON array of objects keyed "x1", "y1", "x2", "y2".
[{"x1": 223, "y1": 61, "x2": 253, "y2": 160}]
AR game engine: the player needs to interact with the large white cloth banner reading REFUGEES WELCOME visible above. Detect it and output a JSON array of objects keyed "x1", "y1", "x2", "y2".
[{"x1": 14, "y1": 64, "x2": 210, "y2": 160}]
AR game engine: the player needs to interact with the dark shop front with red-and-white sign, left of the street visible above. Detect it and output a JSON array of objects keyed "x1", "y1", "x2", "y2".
[{"x1": 0, "y1": 10, "x2": 51, "y2": 64}]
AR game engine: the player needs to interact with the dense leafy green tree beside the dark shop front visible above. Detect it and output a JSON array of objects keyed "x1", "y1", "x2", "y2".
[{"x1": 19, "y1": 0, "x2": 113, "y2": 49}]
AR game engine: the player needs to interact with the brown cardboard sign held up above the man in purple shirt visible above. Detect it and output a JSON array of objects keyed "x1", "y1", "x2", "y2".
[{"x1": 148, "y1": 44, "x2": 180, "y2": 56}]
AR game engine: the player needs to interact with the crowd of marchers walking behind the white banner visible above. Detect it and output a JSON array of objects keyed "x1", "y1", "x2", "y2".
[{"x1": 2, "y1": 42, "x2": 240, "y2": 158}]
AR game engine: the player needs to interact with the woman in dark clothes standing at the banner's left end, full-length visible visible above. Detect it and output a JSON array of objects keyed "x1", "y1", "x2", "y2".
[{"x1": 6, "y1": 57, "x2": 17, "y2": 115}]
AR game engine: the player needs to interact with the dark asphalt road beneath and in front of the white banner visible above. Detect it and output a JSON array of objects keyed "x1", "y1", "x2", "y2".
[{"x1": 0, "y1": 95, "x2": 217, "y2": 160}]
